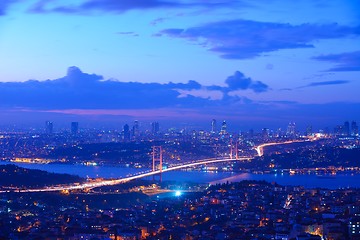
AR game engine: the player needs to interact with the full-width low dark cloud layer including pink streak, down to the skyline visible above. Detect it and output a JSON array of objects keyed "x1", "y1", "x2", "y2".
[{"x1": 0, "y1": 67, "x2": 360, "y2": 127}]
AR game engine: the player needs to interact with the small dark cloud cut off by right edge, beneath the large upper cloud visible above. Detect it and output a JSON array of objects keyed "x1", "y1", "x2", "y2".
[{"x1": 313, "y1": 51, "x2": 360, "y2": 72}]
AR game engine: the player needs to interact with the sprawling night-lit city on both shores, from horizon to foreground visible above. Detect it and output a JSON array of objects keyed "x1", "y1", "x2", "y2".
[{"x1": 0, "y1": 119, "x2": 360, "y2": 240}]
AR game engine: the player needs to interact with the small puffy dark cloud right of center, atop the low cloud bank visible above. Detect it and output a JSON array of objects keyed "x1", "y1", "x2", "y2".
[{"x1": 225, "y1": 71, "x2": 268, "y2": 92}]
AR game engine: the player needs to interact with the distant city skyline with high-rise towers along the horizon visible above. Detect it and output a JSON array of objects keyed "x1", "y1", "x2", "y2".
[{"x1": 5, "y1": 119, "x2": 359, "y2": 137}]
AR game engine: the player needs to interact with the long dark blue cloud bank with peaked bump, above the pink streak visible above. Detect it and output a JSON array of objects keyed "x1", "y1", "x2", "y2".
[{"x1": 0, "y1": 67, "x2": 266, "y2": 110}]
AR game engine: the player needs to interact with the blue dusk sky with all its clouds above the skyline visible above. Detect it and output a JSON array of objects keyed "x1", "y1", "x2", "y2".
[{"x1": 0, "y1": 0, "x2": 360, "y2": 130}]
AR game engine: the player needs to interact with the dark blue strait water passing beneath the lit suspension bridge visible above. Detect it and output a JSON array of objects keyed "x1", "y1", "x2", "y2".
[{"x1": 0, "y1": 162, "x2": 360, "y2": 189}]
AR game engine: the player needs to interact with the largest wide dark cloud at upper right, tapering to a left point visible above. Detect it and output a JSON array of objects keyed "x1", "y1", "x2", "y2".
[{"x1": 156, "y1": 19, "x2": 360, "y2": 59}]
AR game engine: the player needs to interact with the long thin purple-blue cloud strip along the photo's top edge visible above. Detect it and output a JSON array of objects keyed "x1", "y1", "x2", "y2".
[{"x1": 30, "y1": 0, "x2": 238, "y2": 14}]
